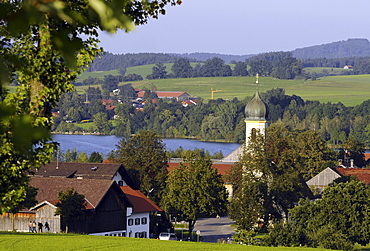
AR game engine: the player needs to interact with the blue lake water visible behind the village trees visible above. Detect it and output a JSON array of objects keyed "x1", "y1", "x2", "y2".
[{"x1": 52, "y1": 134, "x2": 240, "y2": 157}]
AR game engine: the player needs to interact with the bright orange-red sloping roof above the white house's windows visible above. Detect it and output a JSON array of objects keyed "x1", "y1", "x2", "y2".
[{"x1": 120, "y1": 186, "x2": 162, "y2": 213}]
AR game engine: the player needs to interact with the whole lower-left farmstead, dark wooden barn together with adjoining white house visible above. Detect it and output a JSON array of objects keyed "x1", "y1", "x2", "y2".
[{"x1": 0, "y1": 162, "x2": 162, "y2": 238}]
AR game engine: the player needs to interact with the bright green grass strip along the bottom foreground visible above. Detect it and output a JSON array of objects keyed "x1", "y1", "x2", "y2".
[{"x1": 0, "y1": 233, "x2": 332, "y2": 251}]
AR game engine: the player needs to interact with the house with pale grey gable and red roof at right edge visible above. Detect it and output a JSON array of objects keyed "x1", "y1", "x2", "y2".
[{"x1": 306, "y1": 167, "x2": 370, "y2": 194}]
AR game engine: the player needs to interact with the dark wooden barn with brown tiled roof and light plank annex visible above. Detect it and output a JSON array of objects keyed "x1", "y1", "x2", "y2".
[{"x1": 0, "y1": 177, "x2": 133, "y2": 236}]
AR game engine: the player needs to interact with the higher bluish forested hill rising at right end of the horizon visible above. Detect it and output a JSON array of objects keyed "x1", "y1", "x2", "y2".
[{"x1": 292, "y1": 38, "x2": 370, "y2": 59}]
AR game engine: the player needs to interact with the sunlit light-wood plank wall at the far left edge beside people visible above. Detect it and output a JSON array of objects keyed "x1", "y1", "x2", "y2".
[{"x1": 0, "y1": 212, "x2": 36, "y2": 232}]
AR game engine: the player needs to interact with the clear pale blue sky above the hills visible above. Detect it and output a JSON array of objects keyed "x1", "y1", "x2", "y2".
[{"x1": 99, "y1": 0, "x2": 370, "y2": 55}]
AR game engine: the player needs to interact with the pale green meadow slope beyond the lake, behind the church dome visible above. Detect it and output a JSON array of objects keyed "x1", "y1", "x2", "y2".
[{"x1": 77, "y1": 67, "x2": 370, "y2": 106}]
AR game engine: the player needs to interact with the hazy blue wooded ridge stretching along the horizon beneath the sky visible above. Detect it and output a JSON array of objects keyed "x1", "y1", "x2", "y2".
[{"x1": 88, "y1": 39, "x2": 370, "y2": 71}]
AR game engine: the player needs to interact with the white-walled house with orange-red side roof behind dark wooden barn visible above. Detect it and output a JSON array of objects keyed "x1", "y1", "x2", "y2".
[{"x1": 28, "y1": 162, "x2": 162, "y2": 238}]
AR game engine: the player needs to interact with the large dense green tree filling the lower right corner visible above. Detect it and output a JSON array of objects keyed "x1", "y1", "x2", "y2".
[{"x1": 280, "y1": 180, "x2": 370, "y2": 250}]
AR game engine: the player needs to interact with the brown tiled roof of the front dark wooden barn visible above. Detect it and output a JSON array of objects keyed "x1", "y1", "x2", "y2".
[{"x1": 30, "y1": 177, "x2": 116, "y2": 209}]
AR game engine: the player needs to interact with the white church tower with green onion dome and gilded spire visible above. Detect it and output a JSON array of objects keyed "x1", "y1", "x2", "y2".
[{"x1": 244, "y1": 74, "x2": 268, "y2": 146}]
